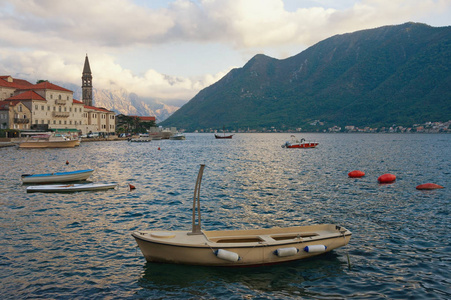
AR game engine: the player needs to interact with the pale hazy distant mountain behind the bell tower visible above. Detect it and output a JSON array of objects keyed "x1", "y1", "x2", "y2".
[{"x1": 56, "y1": 83, "x2": 179, "y2": 122}]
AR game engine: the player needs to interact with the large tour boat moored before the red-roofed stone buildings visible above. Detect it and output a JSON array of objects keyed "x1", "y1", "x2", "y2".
[{"x1": 19, "y1": 133, "x2": 80, "y2": 148}]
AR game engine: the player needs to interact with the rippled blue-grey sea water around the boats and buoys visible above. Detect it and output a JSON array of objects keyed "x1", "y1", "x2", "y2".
[{"x1": 0, "y1": 133, "x2": 451, "y2": 299}]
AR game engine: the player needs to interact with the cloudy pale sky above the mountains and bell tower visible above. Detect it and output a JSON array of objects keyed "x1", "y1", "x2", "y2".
[{"x1": 0, "y1": 0, "x2": 451, "y2": 104}]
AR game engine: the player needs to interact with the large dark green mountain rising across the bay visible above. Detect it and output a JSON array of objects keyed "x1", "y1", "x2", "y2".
[{"x1": 161, "y1": 23, "x2": 451, "y2": 130}]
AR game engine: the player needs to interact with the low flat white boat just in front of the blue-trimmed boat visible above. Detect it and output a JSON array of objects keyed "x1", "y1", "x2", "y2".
[{"x1": 27, "y1": 183, "x2": 117, "y2": 193}]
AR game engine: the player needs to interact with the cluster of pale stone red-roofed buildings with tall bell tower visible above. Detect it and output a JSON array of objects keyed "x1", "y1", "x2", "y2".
[{"x1": 0, "y1": 56, "x2": 116, "y2": 134}]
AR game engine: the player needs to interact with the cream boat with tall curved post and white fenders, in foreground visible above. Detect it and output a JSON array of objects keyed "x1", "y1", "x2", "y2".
[{"x1": 132, "y1": 165, "x2": 351, "y2": 266}]
